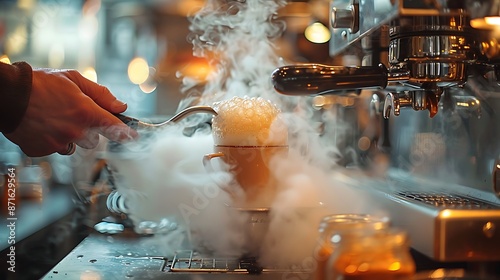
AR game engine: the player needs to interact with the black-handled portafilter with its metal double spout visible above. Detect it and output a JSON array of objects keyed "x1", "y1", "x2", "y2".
[{"x1": 272, "y1": 64, "x2": 452, "y2": 119}]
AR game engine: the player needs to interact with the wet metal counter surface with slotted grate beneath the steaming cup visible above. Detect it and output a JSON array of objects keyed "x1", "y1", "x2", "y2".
[{"x1": 41, "y1": 231, "x2": 304, "y2": 280}]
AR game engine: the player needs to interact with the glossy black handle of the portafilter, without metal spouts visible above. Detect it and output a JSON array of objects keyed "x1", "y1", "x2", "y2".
[{"x1": 272, "y1": 64, "x2": 389, "y2": 95}]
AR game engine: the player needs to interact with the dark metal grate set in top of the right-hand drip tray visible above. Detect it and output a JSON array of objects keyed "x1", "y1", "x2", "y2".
[{"x1": 396, "y1": 191, "x2": 499, "y2": 209}]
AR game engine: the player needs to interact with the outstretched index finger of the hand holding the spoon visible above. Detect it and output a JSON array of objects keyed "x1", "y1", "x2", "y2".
[{"x1": 66, "y1": 70, "x2": 127, "y2": 113}]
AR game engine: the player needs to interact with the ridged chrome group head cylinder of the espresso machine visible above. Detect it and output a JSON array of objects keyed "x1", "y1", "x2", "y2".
[{"x1": 385, "y1": 9, "x2": 479, "y2": 117}]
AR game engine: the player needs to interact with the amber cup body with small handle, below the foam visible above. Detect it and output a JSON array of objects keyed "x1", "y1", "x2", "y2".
[{"x1": 203, "y1": 145, "x2": 288, "y2": 207}]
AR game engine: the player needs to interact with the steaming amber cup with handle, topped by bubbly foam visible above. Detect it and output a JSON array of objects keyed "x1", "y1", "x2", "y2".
[{"x1": 203, "y1": 97, "x2": 288, "y2": 207}]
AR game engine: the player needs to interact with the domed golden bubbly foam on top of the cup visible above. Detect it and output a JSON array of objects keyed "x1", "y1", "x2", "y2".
[{"x1": 212, "y1": 97, "x2": 288, "y2": 146}]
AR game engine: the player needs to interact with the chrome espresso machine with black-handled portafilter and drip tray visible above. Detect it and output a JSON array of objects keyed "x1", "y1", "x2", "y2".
[{"x1": 272, "y1": 0, "x2": 500, "y2": 272}]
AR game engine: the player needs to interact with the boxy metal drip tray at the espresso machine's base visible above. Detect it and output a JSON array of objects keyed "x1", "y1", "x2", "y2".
[{"x1": 353, "y1": 172, "x2": 500, "y2": 262}]
